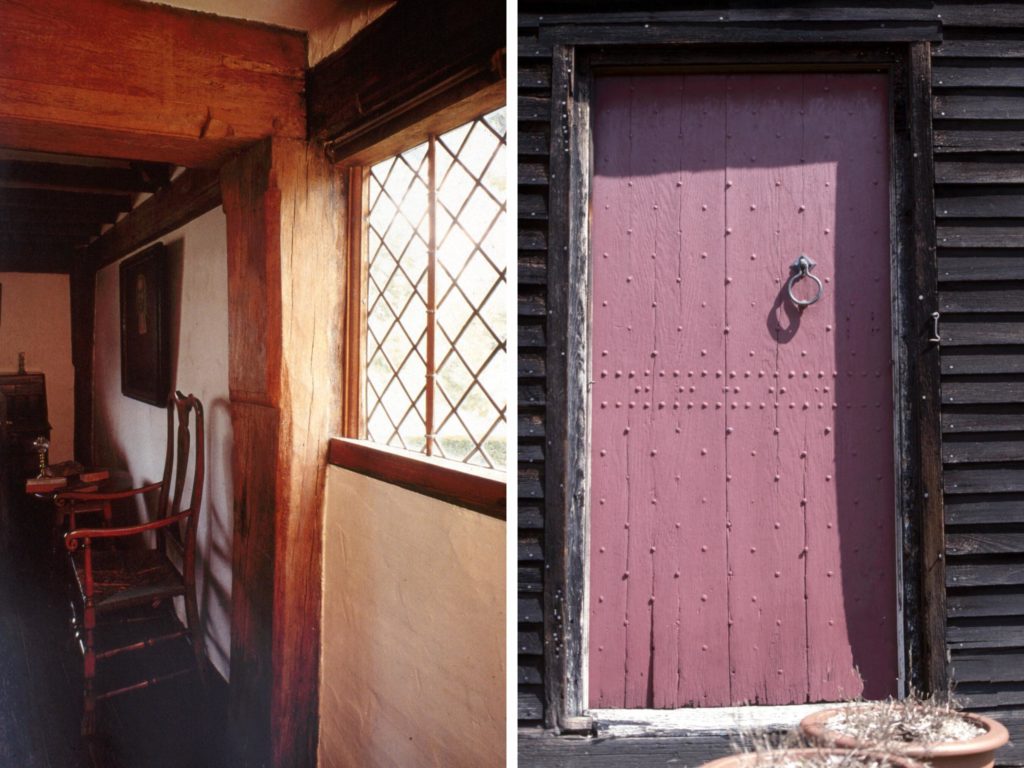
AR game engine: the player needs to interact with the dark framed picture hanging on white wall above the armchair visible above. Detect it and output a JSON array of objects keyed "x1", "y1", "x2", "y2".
[{"x1": 120, "y1": 243, "x2": 171, "y2": 407}]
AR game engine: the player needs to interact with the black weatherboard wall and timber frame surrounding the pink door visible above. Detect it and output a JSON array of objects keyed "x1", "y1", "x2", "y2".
[{"x1": 518, "y1": 0, "x2": 1024, "y2": 766}]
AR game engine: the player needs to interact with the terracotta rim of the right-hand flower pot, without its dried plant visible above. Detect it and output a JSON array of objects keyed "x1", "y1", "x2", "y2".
[{"x1": 800, "y1": 710, "x2": 1010, "y2": 768}]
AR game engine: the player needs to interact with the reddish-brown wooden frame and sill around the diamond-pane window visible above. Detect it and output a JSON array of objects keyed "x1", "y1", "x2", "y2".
[{"x1": 328, "y1": 88, "x2": 505, "y2": 519}]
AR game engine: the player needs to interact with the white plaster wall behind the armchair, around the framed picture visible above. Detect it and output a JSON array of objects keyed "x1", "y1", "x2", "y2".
[{"x1": 91, "y1": 208, "x2": 232, "y2": 678}]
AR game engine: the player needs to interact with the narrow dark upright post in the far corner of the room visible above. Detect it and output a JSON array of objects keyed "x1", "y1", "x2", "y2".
[{"x1": 71, "y1": 258, "x2": 96, "y2": 465}]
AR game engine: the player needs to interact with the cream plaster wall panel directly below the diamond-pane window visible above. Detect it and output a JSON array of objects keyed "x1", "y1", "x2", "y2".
[{"x1": 319, "y1": 467, "x2": 506, "y2": 768}]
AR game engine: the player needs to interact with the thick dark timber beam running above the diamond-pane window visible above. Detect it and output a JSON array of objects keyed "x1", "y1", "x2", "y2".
[{"x1": 308, "y1": 0, "x2": 505, "y2": 162}]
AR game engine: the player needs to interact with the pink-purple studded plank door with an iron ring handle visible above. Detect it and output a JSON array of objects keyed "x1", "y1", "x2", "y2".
[{"x1": 588, "y1": 74, "x2": 897, "y2": 708}]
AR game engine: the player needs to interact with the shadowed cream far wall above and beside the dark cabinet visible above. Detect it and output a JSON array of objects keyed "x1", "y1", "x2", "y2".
[{"x1": 0, "y1": 272, "x2": 75, "y2": 463}]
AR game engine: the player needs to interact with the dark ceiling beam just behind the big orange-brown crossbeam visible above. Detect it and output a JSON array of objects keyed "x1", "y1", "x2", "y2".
[{"x1": 0, "y1": 160, "x2": 169, "y2": 195}]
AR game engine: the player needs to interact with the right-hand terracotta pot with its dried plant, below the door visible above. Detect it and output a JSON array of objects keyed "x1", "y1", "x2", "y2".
[{"x1": 800, "y1": 698, "x2": 1010, "y2": 768}]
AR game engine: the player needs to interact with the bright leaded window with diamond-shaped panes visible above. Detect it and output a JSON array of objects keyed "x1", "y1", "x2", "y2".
[{"x1": 365, "y1": 109, "x2": 508, "y2": 469}]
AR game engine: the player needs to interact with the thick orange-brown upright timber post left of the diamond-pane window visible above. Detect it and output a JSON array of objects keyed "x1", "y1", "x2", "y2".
[{"x1": 221, "y1": 139, "x2": 345, "y2": 767}]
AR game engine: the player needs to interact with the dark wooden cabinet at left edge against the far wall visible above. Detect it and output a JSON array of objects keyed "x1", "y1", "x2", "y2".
[{"x1": 0, "y1": 374, "x2": 50, "y2": 481}]
